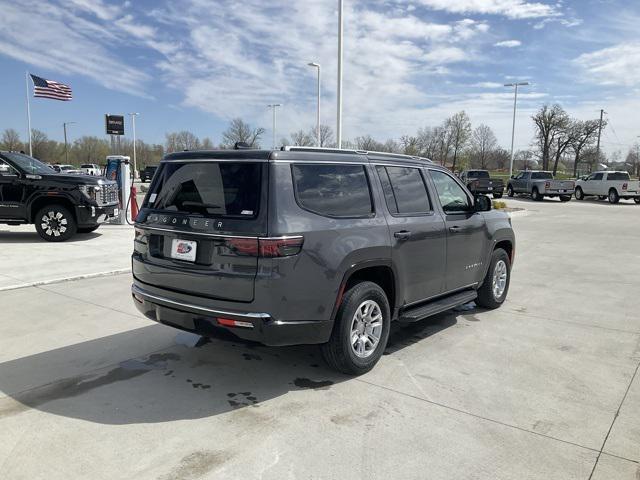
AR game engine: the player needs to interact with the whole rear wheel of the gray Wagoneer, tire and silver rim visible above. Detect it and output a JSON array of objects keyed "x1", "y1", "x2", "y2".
[{"x1": 322, "y1": 282, "x2": 391, "y2": 375}]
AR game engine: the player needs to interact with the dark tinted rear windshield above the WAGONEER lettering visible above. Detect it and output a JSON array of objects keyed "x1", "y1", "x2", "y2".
[{"x1": 147, "y1": 161, "x2": 262, "y2": 218}]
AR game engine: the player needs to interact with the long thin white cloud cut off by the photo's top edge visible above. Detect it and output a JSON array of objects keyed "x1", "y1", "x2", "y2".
[{"x1": 419, "y1": 0, "x2": 558, "y2": 19}]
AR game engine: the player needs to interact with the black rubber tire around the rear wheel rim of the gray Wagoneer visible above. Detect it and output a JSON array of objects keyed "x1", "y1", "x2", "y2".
[{"x1": 322, "y1": 282, "x2": 391, "y2": 375}]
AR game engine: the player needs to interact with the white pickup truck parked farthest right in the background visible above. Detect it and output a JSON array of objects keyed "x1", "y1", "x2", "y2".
[{"x1": 575, "y1": 171, "x2": 640, "y2": 203}]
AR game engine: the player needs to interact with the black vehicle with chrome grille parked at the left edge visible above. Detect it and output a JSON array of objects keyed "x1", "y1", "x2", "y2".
[{"x1": 0, "y1": 152, "x2": 119, "y2": 242}]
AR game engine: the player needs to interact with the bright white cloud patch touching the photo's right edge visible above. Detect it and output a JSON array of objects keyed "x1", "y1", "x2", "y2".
[{"x1": 575, "y1": 42, "x2": 640, "y2": 87}]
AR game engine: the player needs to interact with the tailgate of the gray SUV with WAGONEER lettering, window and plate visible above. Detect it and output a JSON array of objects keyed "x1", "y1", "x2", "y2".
[{"x1": 133, "y1": 160, "x2": 267, "y2": 302}]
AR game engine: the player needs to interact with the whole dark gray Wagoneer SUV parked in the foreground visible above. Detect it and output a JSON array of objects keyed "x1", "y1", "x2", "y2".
[{"x1": 132, "y1": 147, "x2": 515, "y2": 374}]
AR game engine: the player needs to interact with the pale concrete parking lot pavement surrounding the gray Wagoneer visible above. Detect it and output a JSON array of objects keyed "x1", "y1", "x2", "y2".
[{"x1": 0, "y1": 199, "x2": 640, "y2": 480}]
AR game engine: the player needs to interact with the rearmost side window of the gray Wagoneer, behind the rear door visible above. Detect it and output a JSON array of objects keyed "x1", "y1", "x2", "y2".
[{"x1": 291, "y1": 164, "x2": 373, "y2": 218}]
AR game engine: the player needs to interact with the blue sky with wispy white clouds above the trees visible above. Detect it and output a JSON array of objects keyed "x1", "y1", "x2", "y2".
[{"x1": 0, "y1": 0, "x2": 640, "y2": 153}]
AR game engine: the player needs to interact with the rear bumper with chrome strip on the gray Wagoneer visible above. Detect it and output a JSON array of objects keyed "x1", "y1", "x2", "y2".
[{"x1": 131, "y1": 282, "x2": 333, "y2": 346}]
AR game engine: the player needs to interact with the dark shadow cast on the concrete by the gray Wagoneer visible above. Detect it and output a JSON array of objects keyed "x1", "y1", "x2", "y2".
[{"x1": 0, "y1": 312, "x2": 459, "y2": 425}]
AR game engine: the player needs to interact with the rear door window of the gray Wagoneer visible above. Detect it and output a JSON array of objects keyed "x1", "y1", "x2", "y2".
[{"x1": 376, "y1": 165, "x2": 432, "y2": 215}]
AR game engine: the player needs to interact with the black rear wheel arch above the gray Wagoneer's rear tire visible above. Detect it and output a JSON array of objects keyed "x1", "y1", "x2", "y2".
[{"x1": 331, "y1": 260, "x2": 398, "y2": 321}]
